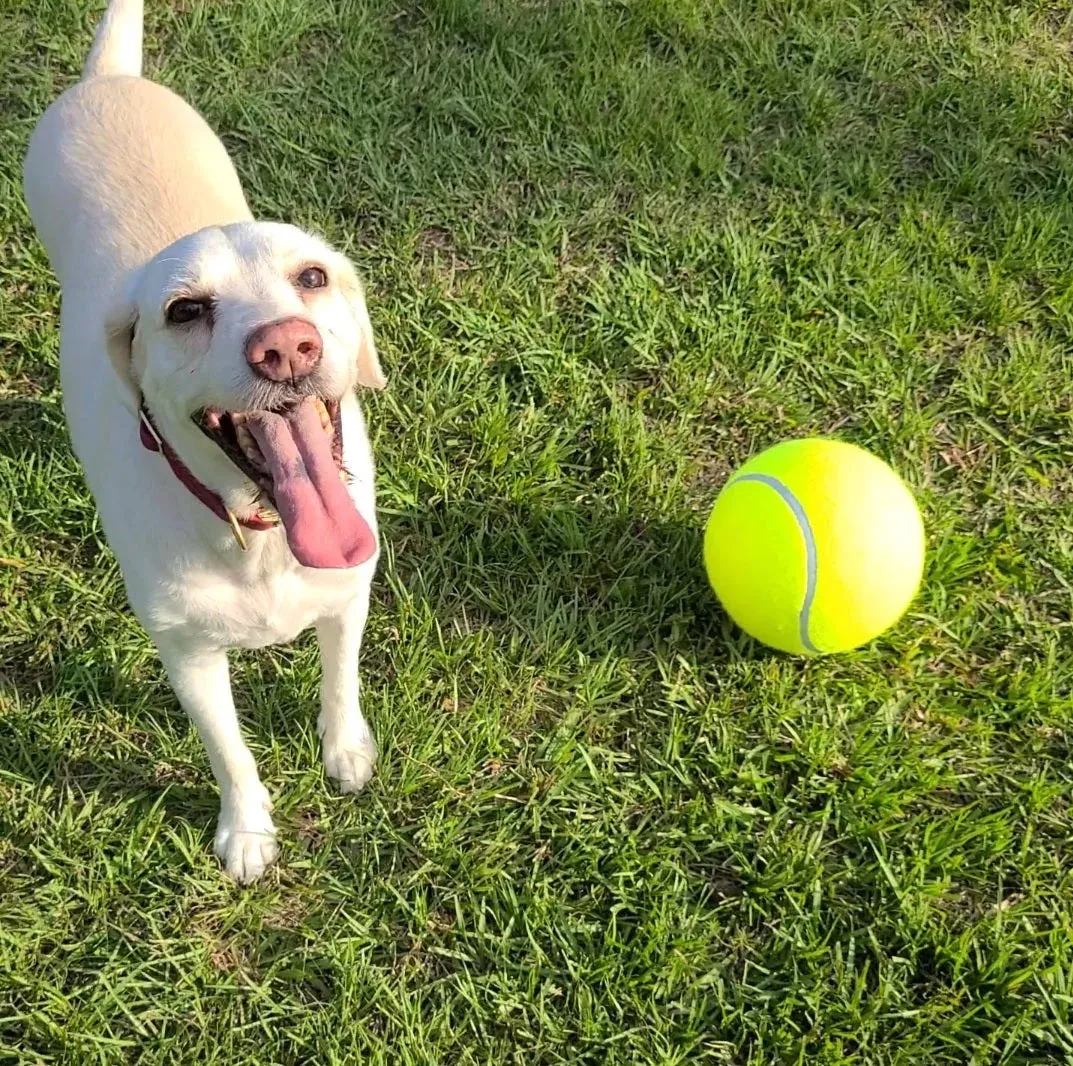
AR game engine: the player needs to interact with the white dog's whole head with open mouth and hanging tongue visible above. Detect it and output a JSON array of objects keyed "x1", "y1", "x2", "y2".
[{"x1": 105, "y1": 222, "x2": 384, "y2": 566}]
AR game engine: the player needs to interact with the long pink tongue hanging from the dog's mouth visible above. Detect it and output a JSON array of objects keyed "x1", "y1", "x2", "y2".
[{"x1": 246, "y1": 399, "x2": 377, "y2": 569}]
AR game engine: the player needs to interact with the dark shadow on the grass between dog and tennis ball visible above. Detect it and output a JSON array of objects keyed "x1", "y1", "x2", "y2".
[{"x1": 382, "y1": 499, "x2": 751, "y2": 665}]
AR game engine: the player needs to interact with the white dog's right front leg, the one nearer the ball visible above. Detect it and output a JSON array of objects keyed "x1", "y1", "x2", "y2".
[{"x1": 317, "y1": 584, "x2": 377, "y2": 792}]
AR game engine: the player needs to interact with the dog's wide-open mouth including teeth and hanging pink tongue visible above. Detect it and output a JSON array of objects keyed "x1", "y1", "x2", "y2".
[{"x1": 194, "y1": 396, "x2": 376, "y2": 569}]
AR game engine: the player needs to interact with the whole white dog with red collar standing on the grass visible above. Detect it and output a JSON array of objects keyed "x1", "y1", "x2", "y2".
[{"x1": 25, "y1": 0, "x2": 383, "y2": 881}]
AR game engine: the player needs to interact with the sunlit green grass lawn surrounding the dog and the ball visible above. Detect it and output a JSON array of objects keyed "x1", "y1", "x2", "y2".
[{"x1": 0, "y1": 0, "x2": 1073, "y2": 1066}]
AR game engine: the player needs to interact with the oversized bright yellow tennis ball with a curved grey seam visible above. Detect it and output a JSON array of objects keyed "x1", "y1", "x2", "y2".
[{"x1": 704, "y1": 438, "x2": 924, "y2": 655}]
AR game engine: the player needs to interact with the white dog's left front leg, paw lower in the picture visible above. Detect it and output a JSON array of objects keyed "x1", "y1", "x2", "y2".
[{"x1": 157, "y1": 640, "x2": 279, "y2": 885}]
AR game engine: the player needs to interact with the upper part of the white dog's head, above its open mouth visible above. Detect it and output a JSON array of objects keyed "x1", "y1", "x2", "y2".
[{"x1": 105, "y1": 222, "x2": 384, "y2": 418}]
